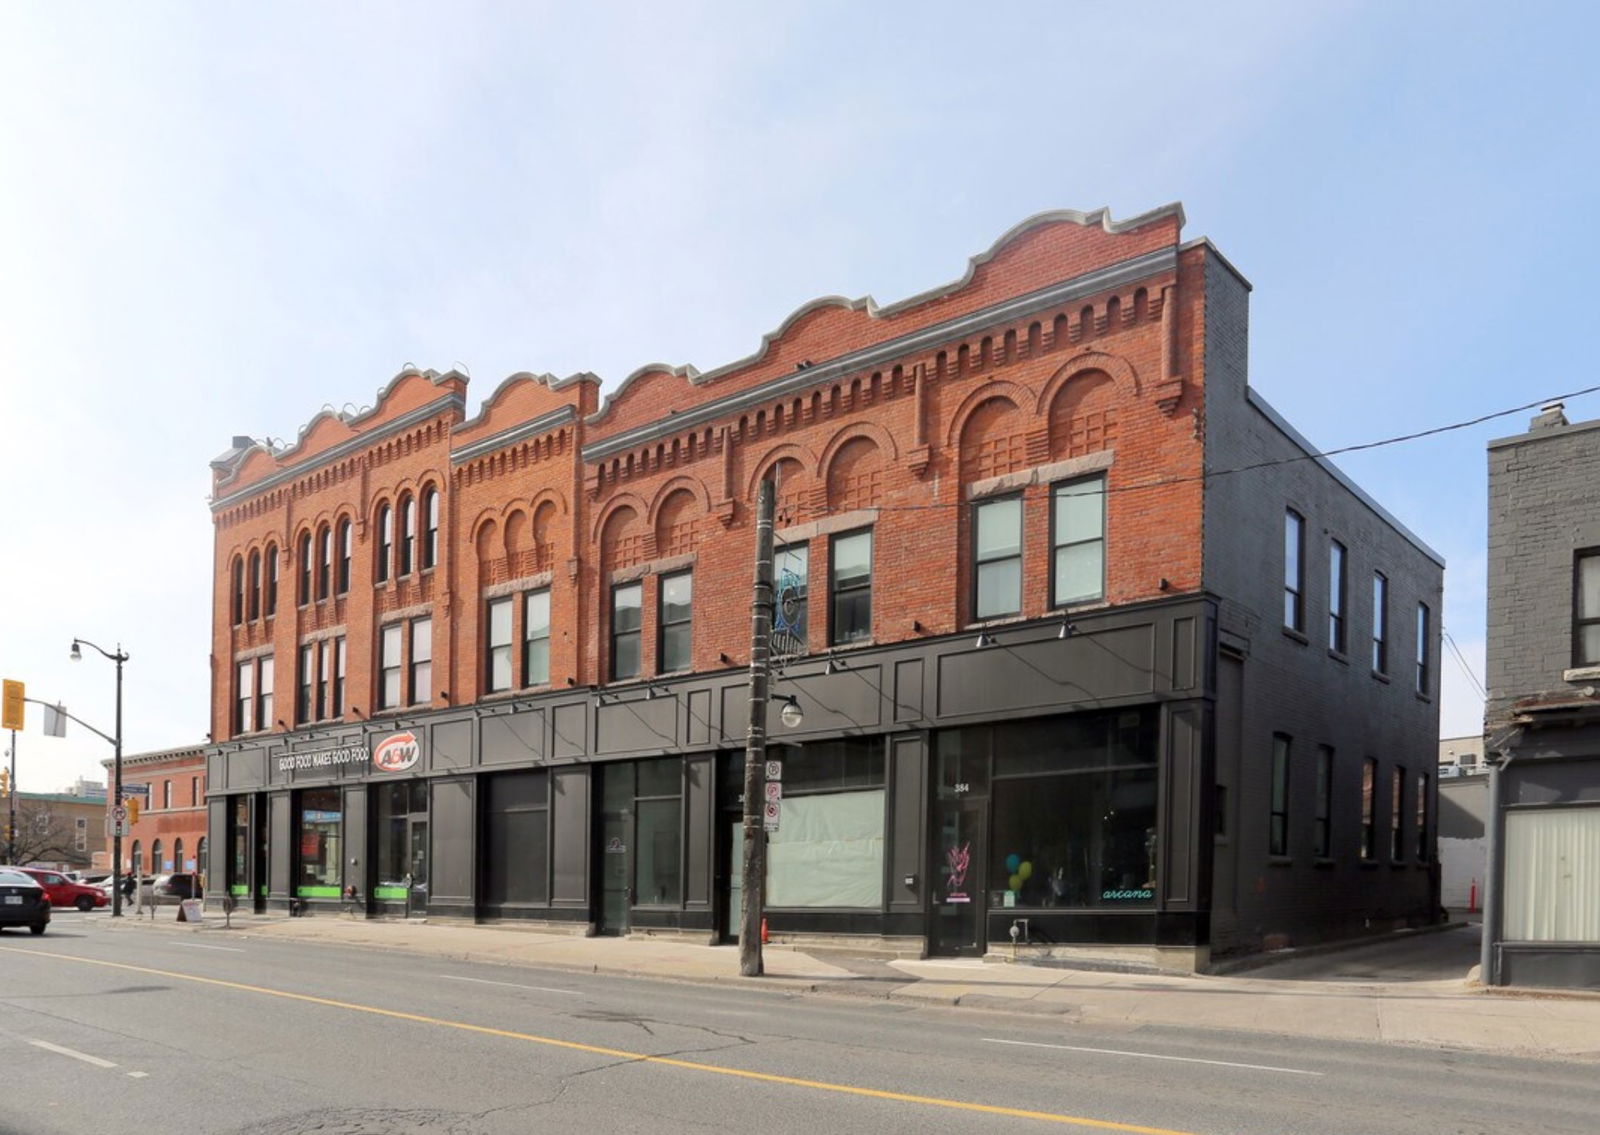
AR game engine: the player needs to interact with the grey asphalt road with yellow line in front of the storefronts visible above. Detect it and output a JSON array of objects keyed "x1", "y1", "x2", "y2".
[{"x1": 0, "y1": 912, "x2": 1600, "y2": 1135}]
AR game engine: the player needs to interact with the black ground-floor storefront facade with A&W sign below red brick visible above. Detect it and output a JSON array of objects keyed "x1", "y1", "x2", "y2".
[{"x1": 208, "y1": 597, "x2": 1216, "y2": 969}]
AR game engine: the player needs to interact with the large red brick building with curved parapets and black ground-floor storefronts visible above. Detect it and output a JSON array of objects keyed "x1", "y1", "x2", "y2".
[{"x1": 210, "y1": 207, "x2": 1440, "y2": 967}]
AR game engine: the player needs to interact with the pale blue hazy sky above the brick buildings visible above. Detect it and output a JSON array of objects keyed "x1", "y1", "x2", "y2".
[{"x1": 0, "y1": 0, "x2": 1600, "y2": 791}]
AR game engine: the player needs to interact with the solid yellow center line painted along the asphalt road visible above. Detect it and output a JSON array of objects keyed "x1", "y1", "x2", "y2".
[{"x1": 0, "y1": 946, "x2": 1194, "y2": 1135}]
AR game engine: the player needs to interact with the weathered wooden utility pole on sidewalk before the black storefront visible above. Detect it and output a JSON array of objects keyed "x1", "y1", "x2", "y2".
[{"x1": 739, "y1": 477, "x2": 774, "y2": 978}]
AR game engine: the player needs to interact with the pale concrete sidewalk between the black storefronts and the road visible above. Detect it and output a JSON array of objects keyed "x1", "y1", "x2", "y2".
[{"x1": 107, "y1": 908, "x2": 1600, "y2": 1060}]
